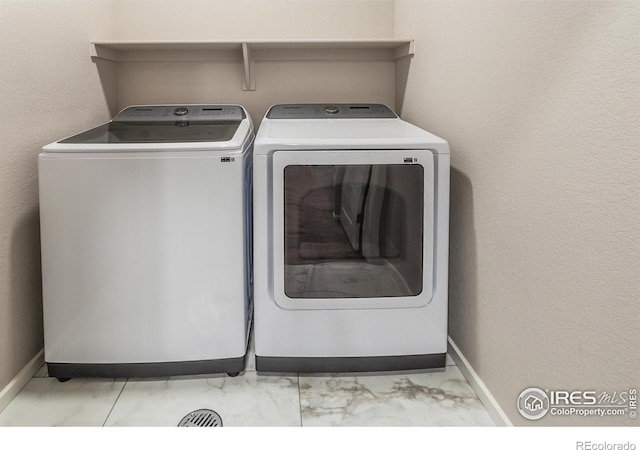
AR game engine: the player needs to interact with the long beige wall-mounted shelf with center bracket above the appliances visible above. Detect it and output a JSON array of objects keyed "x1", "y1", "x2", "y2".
[{"x1": 91, "y1": 39, "x2": 414, "y2": 91}]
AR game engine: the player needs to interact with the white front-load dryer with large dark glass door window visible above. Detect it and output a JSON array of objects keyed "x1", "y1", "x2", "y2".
[{"x1": 254, "y1": 104, "x2": 450, "y2": 373}]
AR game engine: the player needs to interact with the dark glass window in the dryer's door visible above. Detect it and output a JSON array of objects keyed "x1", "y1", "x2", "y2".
[{"x1": 284, "y1": 164, "x2": 424, "y2": 299}]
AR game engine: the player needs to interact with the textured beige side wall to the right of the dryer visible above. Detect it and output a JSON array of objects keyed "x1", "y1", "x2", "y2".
[{"x1": 395, "y1": 0, "x2": 640, "y2": 426}]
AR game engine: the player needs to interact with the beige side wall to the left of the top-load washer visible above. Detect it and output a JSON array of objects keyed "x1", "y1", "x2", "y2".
[{"x1": 0, "y1": 0, "x2": 113, "y2": 391}]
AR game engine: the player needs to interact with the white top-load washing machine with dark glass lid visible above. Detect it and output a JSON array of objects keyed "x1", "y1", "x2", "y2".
[{"x1": 38, "y1": 105, "x2": 254, "y2": 380}]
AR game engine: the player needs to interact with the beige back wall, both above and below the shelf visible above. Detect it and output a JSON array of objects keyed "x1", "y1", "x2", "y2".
[{"x1": 108, "y1": 0, "x2": 395, "y2": 126}]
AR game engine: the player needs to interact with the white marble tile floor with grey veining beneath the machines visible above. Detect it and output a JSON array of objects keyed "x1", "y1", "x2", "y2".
[{"x1": 0, "y1": 342, "x2": 494, "y2": 427}]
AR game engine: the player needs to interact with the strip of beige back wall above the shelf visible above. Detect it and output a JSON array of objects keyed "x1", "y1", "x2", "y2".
[{"x1": 112, "y1": 0, "x2": 394, "y2": 40}]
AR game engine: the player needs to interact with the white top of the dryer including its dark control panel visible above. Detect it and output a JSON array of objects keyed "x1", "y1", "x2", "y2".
[{"x1": 254, "y1": 104, "x2": 449, "y2": 154}]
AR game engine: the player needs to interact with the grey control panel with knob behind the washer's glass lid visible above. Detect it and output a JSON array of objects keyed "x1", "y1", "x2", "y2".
[{"x1": 113, "y1": 105, "x2": 246, "y2": 122}]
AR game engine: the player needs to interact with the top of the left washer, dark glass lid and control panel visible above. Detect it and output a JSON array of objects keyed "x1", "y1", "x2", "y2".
[{"x1": 43, "y1": 105, "x2": 253, "y2": 153}]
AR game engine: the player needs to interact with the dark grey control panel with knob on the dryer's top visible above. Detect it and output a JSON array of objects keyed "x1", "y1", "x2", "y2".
[{"x1": 267, "y1": 103, "x2": 398, "y2": 119}]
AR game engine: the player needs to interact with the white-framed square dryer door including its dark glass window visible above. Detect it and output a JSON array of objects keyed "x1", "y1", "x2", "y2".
[{"x1": 273, "y1": 150, "x2": 435, "y2": 309}]
